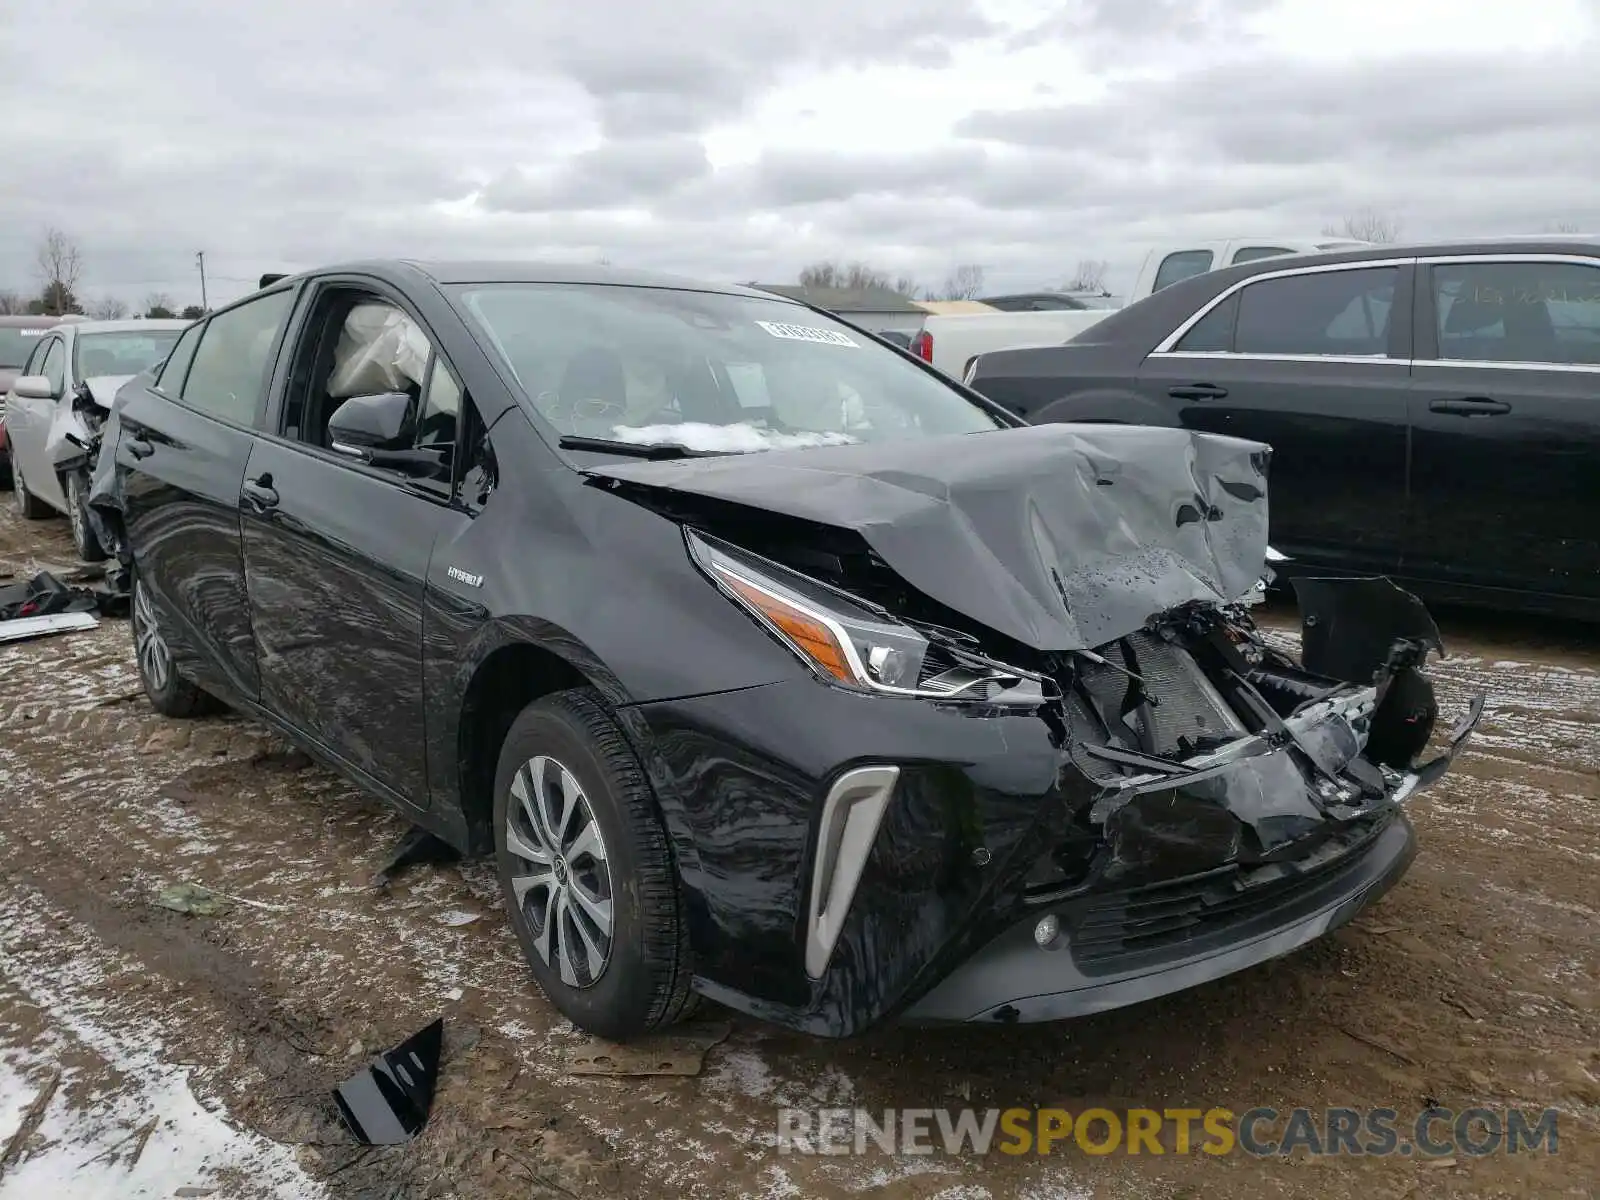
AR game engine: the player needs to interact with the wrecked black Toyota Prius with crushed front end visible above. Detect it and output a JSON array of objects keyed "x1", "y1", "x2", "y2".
[{"x1": 93, "y1": 262, "x2": 1482, "y2": 1038}]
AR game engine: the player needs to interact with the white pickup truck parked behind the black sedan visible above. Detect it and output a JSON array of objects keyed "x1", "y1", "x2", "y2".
[{"x1": 910, "y1": 237, "x2": 1363, "y2": 378}]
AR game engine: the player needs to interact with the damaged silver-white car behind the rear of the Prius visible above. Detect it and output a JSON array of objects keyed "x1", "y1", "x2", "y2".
[{"x1": 5, "y1": 320, "x2": 190, "y2": 562}]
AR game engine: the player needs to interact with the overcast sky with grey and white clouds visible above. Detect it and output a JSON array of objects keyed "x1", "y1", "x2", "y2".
[{"x1": 0, "y1": 0, "x2": 1600, "y2": 304}]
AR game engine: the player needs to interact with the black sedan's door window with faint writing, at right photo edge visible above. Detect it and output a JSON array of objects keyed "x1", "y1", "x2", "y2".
[{"x1": 1434, "y1": 262, "x2": 1600, "y2": 365}]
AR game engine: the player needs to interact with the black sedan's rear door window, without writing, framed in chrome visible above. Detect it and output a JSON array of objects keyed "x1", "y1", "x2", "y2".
[{"x1": 1234, "y1": 267, "x2": 1400, "y2": 357}]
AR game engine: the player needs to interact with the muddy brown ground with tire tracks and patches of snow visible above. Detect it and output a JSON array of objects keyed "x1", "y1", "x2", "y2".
[{"x1": 0, "y1": 496, "x2": 1600, "y2": 1200}]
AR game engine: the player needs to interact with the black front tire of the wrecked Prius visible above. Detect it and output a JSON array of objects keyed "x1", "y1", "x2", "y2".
[{"x1": 494, "y1": 688, "x2": 696, "y2": 1042}]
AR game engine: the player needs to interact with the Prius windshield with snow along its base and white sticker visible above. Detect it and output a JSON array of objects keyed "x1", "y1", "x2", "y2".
[{"x1": 454, "y1": 283, "x2": 1002, "y2": 451}]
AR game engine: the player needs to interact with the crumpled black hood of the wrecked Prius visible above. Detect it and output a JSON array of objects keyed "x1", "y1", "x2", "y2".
[{"x1": 586, "y1": 424, "x2": 1270, "y2": 651}]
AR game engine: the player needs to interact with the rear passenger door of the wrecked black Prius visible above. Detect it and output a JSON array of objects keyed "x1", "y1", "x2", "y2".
[{"x1": 117, "y1": 288, "x2": 294, "y2": 701}]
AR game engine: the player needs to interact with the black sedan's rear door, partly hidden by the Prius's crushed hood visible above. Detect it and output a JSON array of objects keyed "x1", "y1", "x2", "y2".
[{"x1": 1139, "y1": 261, "x2": 1413, "y2": 573}]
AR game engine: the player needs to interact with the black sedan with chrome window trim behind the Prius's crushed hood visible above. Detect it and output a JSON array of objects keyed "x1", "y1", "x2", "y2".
[{"x1": 968, "y1": 235, "x2": 1600, "y2": 619}]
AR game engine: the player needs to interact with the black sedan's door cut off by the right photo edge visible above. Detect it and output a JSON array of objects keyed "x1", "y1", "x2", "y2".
[{"x1": 1405, "y1": 254, "x2": 1600, "y2": 598}]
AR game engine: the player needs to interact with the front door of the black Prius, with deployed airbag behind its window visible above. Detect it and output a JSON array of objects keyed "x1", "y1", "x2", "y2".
[{"x1": 242, "y1": 280, "x2": 469, "y2": 808}]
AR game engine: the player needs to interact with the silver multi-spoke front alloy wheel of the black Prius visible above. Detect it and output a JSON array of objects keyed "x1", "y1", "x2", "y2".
[{"x1": 506, "y1": 755, "x2": 613, "y2": 987}]
